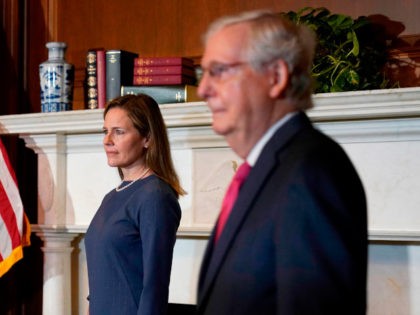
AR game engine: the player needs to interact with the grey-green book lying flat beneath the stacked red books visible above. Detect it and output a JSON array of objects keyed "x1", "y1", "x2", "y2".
[{"x1": 121, "y1": 84, "x2": 202, "y2": 104}]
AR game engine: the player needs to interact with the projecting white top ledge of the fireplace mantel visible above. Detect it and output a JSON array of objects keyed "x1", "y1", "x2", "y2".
[{"x1": 4, "y1": 87, "x2": 420, "y2": 134}]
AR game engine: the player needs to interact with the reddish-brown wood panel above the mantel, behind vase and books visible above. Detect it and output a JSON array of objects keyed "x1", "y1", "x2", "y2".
[{"x1": 22, "y1": 0, "x2": 420, "y2": 112}]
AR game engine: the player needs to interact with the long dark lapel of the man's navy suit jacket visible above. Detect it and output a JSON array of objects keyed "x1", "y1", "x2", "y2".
[{"x1": 198, "y1": 113, "x2": 310, "y2": 304}]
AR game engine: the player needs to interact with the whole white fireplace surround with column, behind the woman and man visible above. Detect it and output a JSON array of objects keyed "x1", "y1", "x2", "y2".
[{"x1": 0, "y1": 87, "x2": 420, "y2": 314}]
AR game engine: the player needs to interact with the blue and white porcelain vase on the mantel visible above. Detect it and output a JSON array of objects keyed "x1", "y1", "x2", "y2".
[{"x1": 39, "y1": 42, "x2": 74, "y2": 112}]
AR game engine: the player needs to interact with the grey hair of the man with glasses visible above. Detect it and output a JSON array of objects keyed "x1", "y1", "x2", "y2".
[{"x1": 204, "y1": 10, "x2": 316, "y2": 110}]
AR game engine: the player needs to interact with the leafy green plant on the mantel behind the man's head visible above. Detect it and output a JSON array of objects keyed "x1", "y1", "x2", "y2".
[{"x1": 281, "y1": 7, "x2": 395, "y2": 93}]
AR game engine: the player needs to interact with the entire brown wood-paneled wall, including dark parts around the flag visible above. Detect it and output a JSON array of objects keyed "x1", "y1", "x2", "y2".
[{"x1": 0, "y1": 0, "x2": 420, "y2": 315}]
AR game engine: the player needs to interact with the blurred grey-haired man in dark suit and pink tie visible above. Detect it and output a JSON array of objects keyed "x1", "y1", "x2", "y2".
[{"x1": 197, "y1": 11, "x2": 367, "y2": 315}]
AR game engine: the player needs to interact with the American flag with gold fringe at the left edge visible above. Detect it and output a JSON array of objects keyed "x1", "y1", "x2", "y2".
[{"x1": 0, "y1": 139, "x2": 31, "y2": 277}]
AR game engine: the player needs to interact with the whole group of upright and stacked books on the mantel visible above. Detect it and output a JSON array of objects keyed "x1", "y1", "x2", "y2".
[{"x1": 86, "y1": 48, "x2": 199, "y2": 109}]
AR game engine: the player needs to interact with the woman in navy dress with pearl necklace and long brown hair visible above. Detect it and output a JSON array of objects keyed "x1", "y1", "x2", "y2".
[{"x1": 85, "y1": 95, "x2": 185, "y2": 315}]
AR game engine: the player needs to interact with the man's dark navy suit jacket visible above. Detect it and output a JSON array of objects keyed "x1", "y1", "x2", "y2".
[{"x1": 197, "y1": 113, "x2": 367, "y2": 315}]
